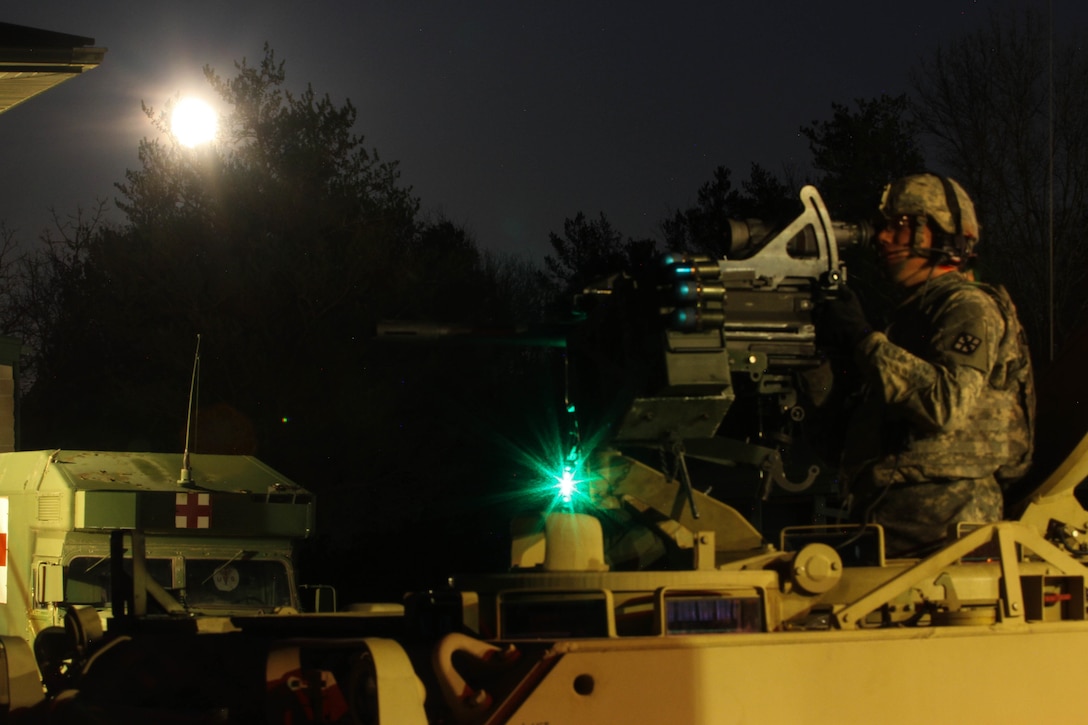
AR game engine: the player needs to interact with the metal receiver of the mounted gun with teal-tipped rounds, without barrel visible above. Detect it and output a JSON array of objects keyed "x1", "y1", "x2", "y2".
[{"x1": 617, "y1": 186, "x2": 852, "y2": 424}]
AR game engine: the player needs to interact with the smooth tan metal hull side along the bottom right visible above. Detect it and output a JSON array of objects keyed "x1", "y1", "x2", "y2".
[{"x1": 505, "y1": 623, "x2": 1088, "y2": 725}]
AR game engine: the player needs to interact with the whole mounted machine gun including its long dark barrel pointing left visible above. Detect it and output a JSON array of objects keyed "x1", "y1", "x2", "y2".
[{"x1": 378, "y1": 186, "x2": 871, "y2": 503}]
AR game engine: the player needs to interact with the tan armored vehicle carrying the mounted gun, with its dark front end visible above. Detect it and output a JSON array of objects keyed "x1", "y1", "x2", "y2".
[{"x1": 5, "y1": 187, "x2": 1088, "y2": 723}]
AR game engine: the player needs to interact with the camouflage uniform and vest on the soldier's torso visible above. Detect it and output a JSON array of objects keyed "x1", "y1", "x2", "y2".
[{"x1": 844, "y1": 272, "x2": 1035, "y2": 556}]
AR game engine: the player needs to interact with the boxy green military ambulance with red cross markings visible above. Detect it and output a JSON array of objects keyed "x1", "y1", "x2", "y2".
[{"x1": 0, "y1": 451, "x2": 314, "y2": 641}]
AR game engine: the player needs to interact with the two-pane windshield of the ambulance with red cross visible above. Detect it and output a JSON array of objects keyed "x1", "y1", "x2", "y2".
[{"x1": 64, "y1": 556, "x2": 290, "y2": 611}]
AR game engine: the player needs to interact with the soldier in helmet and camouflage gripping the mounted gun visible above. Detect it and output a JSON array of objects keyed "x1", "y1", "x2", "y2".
[{"x1": 823, "y1": 174, "x2": 1035, "y2": 557}]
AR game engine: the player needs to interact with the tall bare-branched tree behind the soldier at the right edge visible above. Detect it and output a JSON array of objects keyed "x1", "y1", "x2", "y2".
[{"x1": 913, "y1": 9, "x2": 1088, "y2": 359}]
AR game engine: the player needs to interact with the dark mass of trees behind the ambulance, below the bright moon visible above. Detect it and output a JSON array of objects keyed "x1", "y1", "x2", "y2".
[{"x1": 6, "y1": 49, "x2": 552, "y2": 587}]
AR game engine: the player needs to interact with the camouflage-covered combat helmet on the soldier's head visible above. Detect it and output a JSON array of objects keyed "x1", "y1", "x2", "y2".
[{"x1": 880, "y1": 173, "x2": 979, "y2": 265}]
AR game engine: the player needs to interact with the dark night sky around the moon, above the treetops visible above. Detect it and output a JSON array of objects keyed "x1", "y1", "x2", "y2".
[{"x1": 0, "y1": 0, "x2": 1088, "y2": 260}]
